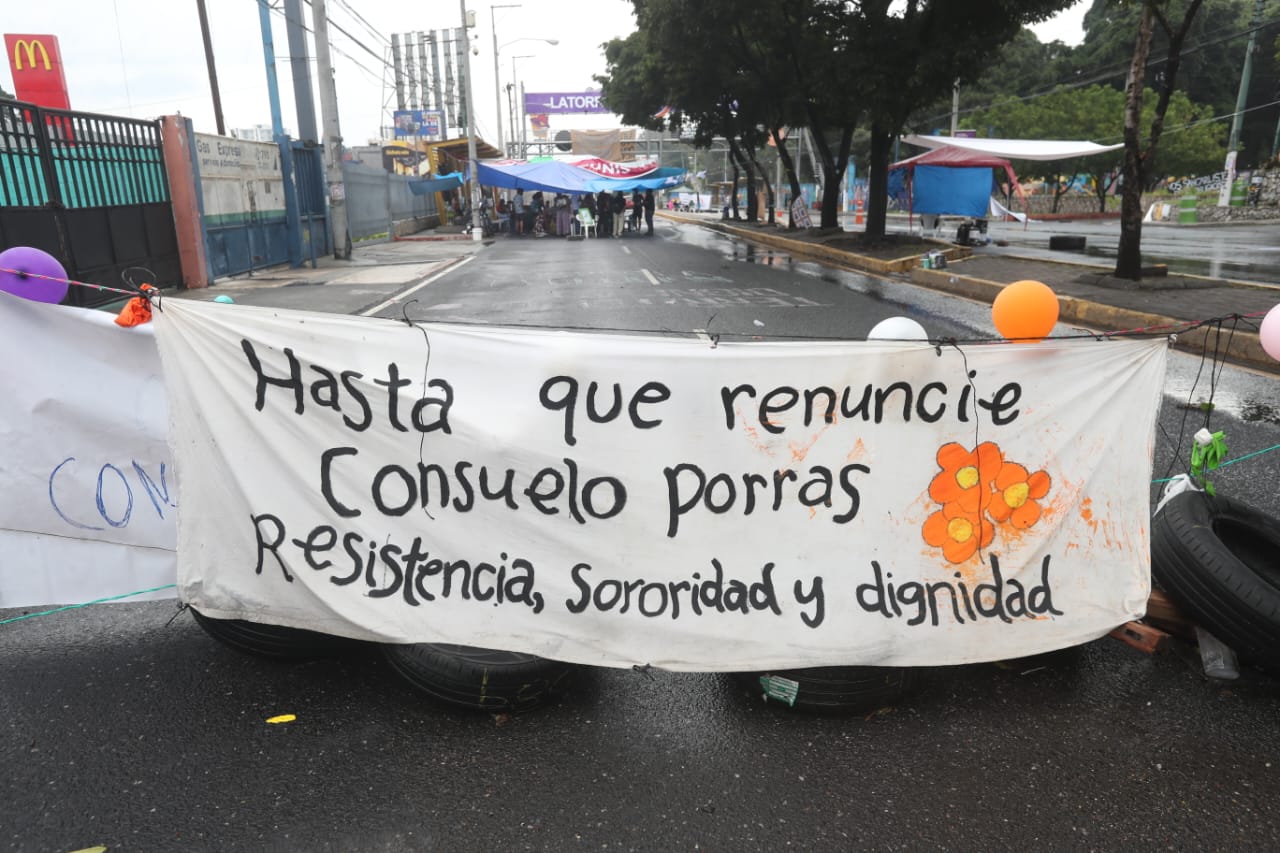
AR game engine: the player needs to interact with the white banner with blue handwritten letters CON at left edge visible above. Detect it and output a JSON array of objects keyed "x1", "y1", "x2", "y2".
[{"x1": 0, "y1": 293, "x2": 178, "y2": 607}]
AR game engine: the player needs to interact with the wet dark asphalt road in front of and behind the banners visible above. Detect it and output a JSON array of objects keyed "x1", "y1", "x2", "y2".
[{"x1": 0, "y1": 225, "x2": 1280, "y2": 853}]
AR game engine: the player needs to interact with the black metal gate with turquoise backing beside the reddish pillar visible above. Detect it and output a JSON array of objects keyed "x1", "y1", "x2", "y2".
[{"x1": 0, "y1": 101, "x2": 182, "y2": 306}]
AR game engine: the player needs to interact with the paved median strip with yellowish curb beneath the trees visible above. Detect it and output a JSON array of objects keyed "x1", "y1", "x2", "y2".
[{"x1": 663, "y1": 213, "x2": 1280, "y2": 374}]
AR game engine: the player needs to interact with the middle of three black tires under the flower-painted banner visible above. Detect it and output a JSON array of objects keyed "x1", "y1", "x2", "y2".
[{"x1": 383, "y1": 643, "x2": 575, "y2": 712}]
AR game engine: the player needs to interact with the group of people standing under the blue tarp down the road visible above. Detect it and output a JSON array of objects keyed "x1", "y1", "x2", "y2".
[{"x1": 498, "y1": 190, "x2": 655, "y2": 237}]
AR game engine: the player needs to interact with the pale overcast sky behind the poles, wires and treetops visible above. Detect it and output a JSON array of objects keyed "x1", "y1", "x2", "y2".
[{"x1": 0, "y1": 0, "x2": 1089, "y2": 145}]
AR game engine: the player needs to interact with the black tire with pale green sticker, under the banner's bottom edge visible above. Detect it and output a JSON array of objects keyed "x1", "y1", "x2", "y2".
[{"x1": 733, "y1": 666, "x2": 916, "y2": 713}]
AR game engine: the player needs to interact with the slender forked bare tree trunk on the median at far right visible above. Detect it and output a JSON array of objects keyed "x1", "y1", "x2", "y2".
[{"x1": 1115, "y1": 0, "x2": 1203, "y2": 280}]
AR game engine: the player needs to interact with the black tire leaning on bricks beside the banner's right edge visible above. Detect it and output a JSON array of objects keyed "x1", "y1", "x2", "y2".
[{"x1": 1151, "y1": 492, "x2": 1280, "y2": 672}]
